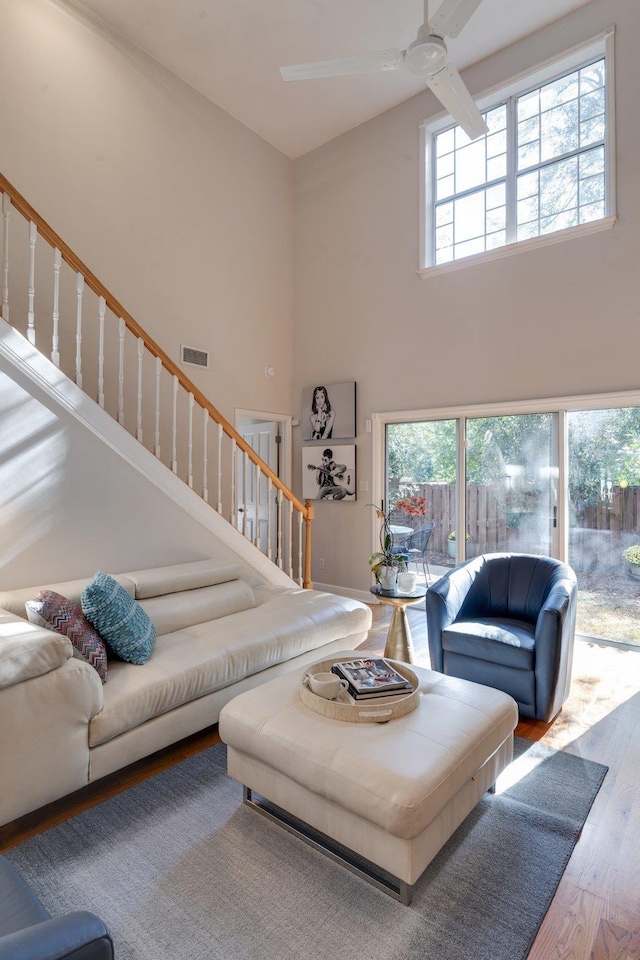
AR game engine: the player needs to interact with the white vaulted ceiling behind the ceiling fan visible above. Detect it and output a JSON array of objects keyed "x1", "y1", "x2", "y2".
[{"x1": 74, "y1": 0, "x2": 589, "y2": 158}]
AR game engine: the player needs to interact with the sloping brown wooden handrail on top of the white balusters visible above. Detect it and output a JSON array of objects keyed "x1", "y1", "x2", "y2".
[{"x1": 0, "y1": 173, "x2": 313, "y2": 520}]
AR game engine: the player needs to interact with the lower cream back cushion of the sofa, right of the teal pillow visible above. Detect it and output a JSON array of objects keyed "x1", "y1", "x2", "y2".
[{"x1": 140, "y1": 580, "x2": 256, "y2": 636}]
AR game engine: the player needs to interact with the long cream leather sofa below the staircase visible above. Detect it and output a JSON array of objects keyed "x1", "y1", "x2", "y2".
[{"x1": 0, "y1": 560, "x2": 371, "y2": 824}]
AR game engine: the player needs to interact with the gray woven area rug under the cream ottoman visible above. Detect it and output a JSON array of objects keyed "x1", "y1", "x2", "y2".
[{"x1": 7, "y1": 739, "x2": 607, "y2": 960}]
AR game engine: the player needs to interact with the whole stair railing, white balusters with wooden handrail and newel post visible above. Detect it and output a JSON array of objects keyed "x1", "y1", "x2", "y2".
[{"x1": 0, "y1": 174, "x2": 313, "y2": 587}]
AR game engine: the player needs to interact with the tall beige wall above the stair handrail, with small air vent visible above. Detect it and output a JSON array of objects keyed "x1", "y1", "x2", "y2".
[{"x1": 0, "y1": 0, "x2": 292, "y2": 421}]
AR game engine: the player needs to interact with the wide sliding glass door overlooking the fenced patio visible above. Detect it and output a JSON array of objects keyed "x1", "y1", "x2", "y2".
[{"x1": 384, "y1": 394, "x2": 640, "y2": 646}]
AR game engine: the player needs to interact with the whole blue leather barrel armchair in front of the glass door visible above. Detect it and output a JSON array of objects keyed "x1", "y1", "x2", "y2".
[{"x1": 426, "y1": 553, "x2": 577, "y2": 723}]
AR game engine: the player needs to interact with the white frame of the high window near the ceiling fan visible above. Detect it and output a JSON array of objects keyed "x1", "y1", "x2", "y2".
[{"x1": 418, "y1": 26, "x2": 617, "y2": 278}]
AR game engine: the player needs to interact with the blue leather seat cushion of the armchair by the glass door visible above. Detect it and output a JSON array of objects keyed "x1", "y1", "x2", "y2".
[{"x1": 442, "y1": 617, "x2": 535, "y2": 670}]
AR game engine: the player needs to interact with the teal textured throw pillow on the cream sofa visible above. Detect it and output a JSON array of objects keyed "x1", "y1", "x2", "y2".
[{"x1": 80, "y1": 573, "x2": 156, "y2": 663}]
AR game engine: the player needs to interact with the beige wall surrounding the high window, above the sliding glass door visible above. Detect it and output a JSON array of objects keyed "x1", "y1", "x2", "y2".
[{"x1": 294, "y1": 0, "x2": 640, "y2": 590}]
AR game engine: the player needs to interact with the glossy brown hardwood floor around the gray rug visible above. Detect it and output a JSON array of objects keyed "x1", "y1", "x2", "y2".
[{"x1": 0, "y1": 605, "x2": 640, "y2": 960}]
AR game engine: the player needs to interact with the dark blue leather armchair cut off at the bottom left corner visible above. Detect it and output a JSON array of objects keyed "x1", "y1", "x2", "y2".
[{"x1": 0, "y1": 857, "x2": 113, "y2": 960}]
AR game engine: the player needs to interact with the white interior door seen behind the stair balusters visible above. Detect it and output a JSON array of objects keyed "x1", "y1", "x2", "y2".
[{"x1": 237, "y1": 421, "x2": 280, "y2": 557}]
